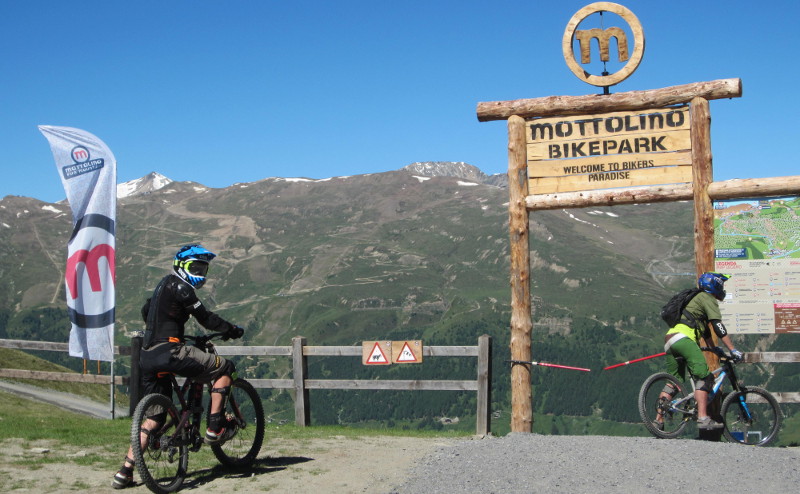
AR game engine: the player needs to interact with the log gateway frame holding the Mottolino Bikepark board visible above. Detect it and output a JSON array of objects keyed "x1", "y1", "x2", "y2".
[{"x1": 477, "y1": 2, "x2": 800, "y2": 432}]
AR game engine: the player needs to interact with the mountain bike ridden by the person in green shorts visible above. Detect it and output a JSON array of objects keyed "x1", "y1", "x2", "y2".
[{"x1": 639, "y1": 348, "x2": 783, "y2": 446}]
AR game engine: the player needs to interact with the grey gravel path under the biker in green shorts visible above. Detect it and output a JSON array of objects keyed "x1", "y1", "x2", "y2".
[{"x1": 390, "y1": 433, "x2": 800, "y2": 494}]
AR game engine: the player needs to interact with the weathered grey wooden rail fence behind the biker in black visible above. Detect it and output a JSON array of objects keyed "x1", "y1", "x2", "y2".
[{"x1": 0, "y1": 335, "x2": 492, "y2": 435}]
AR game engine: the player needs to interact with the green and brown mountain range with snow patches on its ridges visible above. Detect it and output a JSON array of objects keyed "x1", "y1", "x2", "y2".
[{"x1": 0, "y1": 162, "x2": 788, "y2": 432}]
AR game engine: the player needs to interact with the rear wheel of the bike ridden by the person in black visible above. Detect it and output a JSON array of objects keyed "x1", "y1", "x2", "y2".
[{"x1": 131, "y1": 393, "x2": 189, "y2": 494}]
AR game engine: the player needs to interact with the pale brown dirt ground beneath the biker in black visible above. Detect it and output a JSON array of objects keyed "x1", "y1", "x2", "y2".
[{"x1": 0, "y1": 437, "x2": 452, "y2": 494}]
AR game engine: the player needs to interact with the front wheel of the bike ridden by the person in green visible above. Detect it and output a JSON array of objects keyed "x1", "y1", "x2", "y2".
[{"x1": 721, "y1": 387, "x2": 782, "y2": 446}]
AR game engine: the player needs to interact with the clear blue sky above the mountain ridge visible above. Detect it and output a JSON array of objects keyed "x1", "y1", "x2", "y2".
[{"x1": 0, "y1": 0, "x2": 800, "y2": 202}]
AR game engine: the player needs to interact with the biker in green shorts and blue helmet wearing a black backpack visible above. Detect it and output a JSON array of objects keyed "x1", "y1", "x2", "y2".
[{"x1": 655, "y1": 272, "x2": 744, "y2": 430}]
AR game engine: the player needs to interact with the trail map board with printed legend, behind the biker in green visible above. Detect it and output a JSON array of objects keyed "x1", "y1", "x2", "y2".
[{"x1": 714, "y1": 197, "x2": 800, "y2": 333}]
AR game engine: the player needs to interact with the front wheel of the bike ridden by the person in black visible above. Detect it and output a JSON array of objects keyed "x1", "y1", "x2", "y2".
[{"x1": 211, "y1": 379, "x2": 264, "y2": 467}]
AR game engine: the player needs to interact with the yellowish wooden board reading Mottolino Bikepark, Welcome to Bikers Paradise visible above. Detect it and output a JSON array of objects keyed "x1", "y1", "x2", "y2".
[{"x1": 525, "y1": 107, "x2": 692, "y2": 194}]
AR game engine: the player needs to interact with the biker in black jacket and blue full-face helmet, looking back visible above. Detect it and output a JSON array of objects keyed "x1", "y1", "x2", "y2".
[{"x1": 113, "y1": 244, "x2": 244, "y2": 489}]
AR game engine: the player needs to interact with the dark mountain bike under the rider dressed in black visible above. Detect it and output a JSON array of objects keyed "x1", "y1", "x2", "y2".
[{"x1": 131, "y1": 333, "x2": 264, "y2": 494}]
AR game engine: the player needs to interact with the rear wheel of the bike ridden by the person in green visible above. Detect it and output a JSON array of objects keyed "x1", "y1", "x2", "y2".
[{"x1": 639, "y1": 372, "x2": 694, "y2": 439}]
